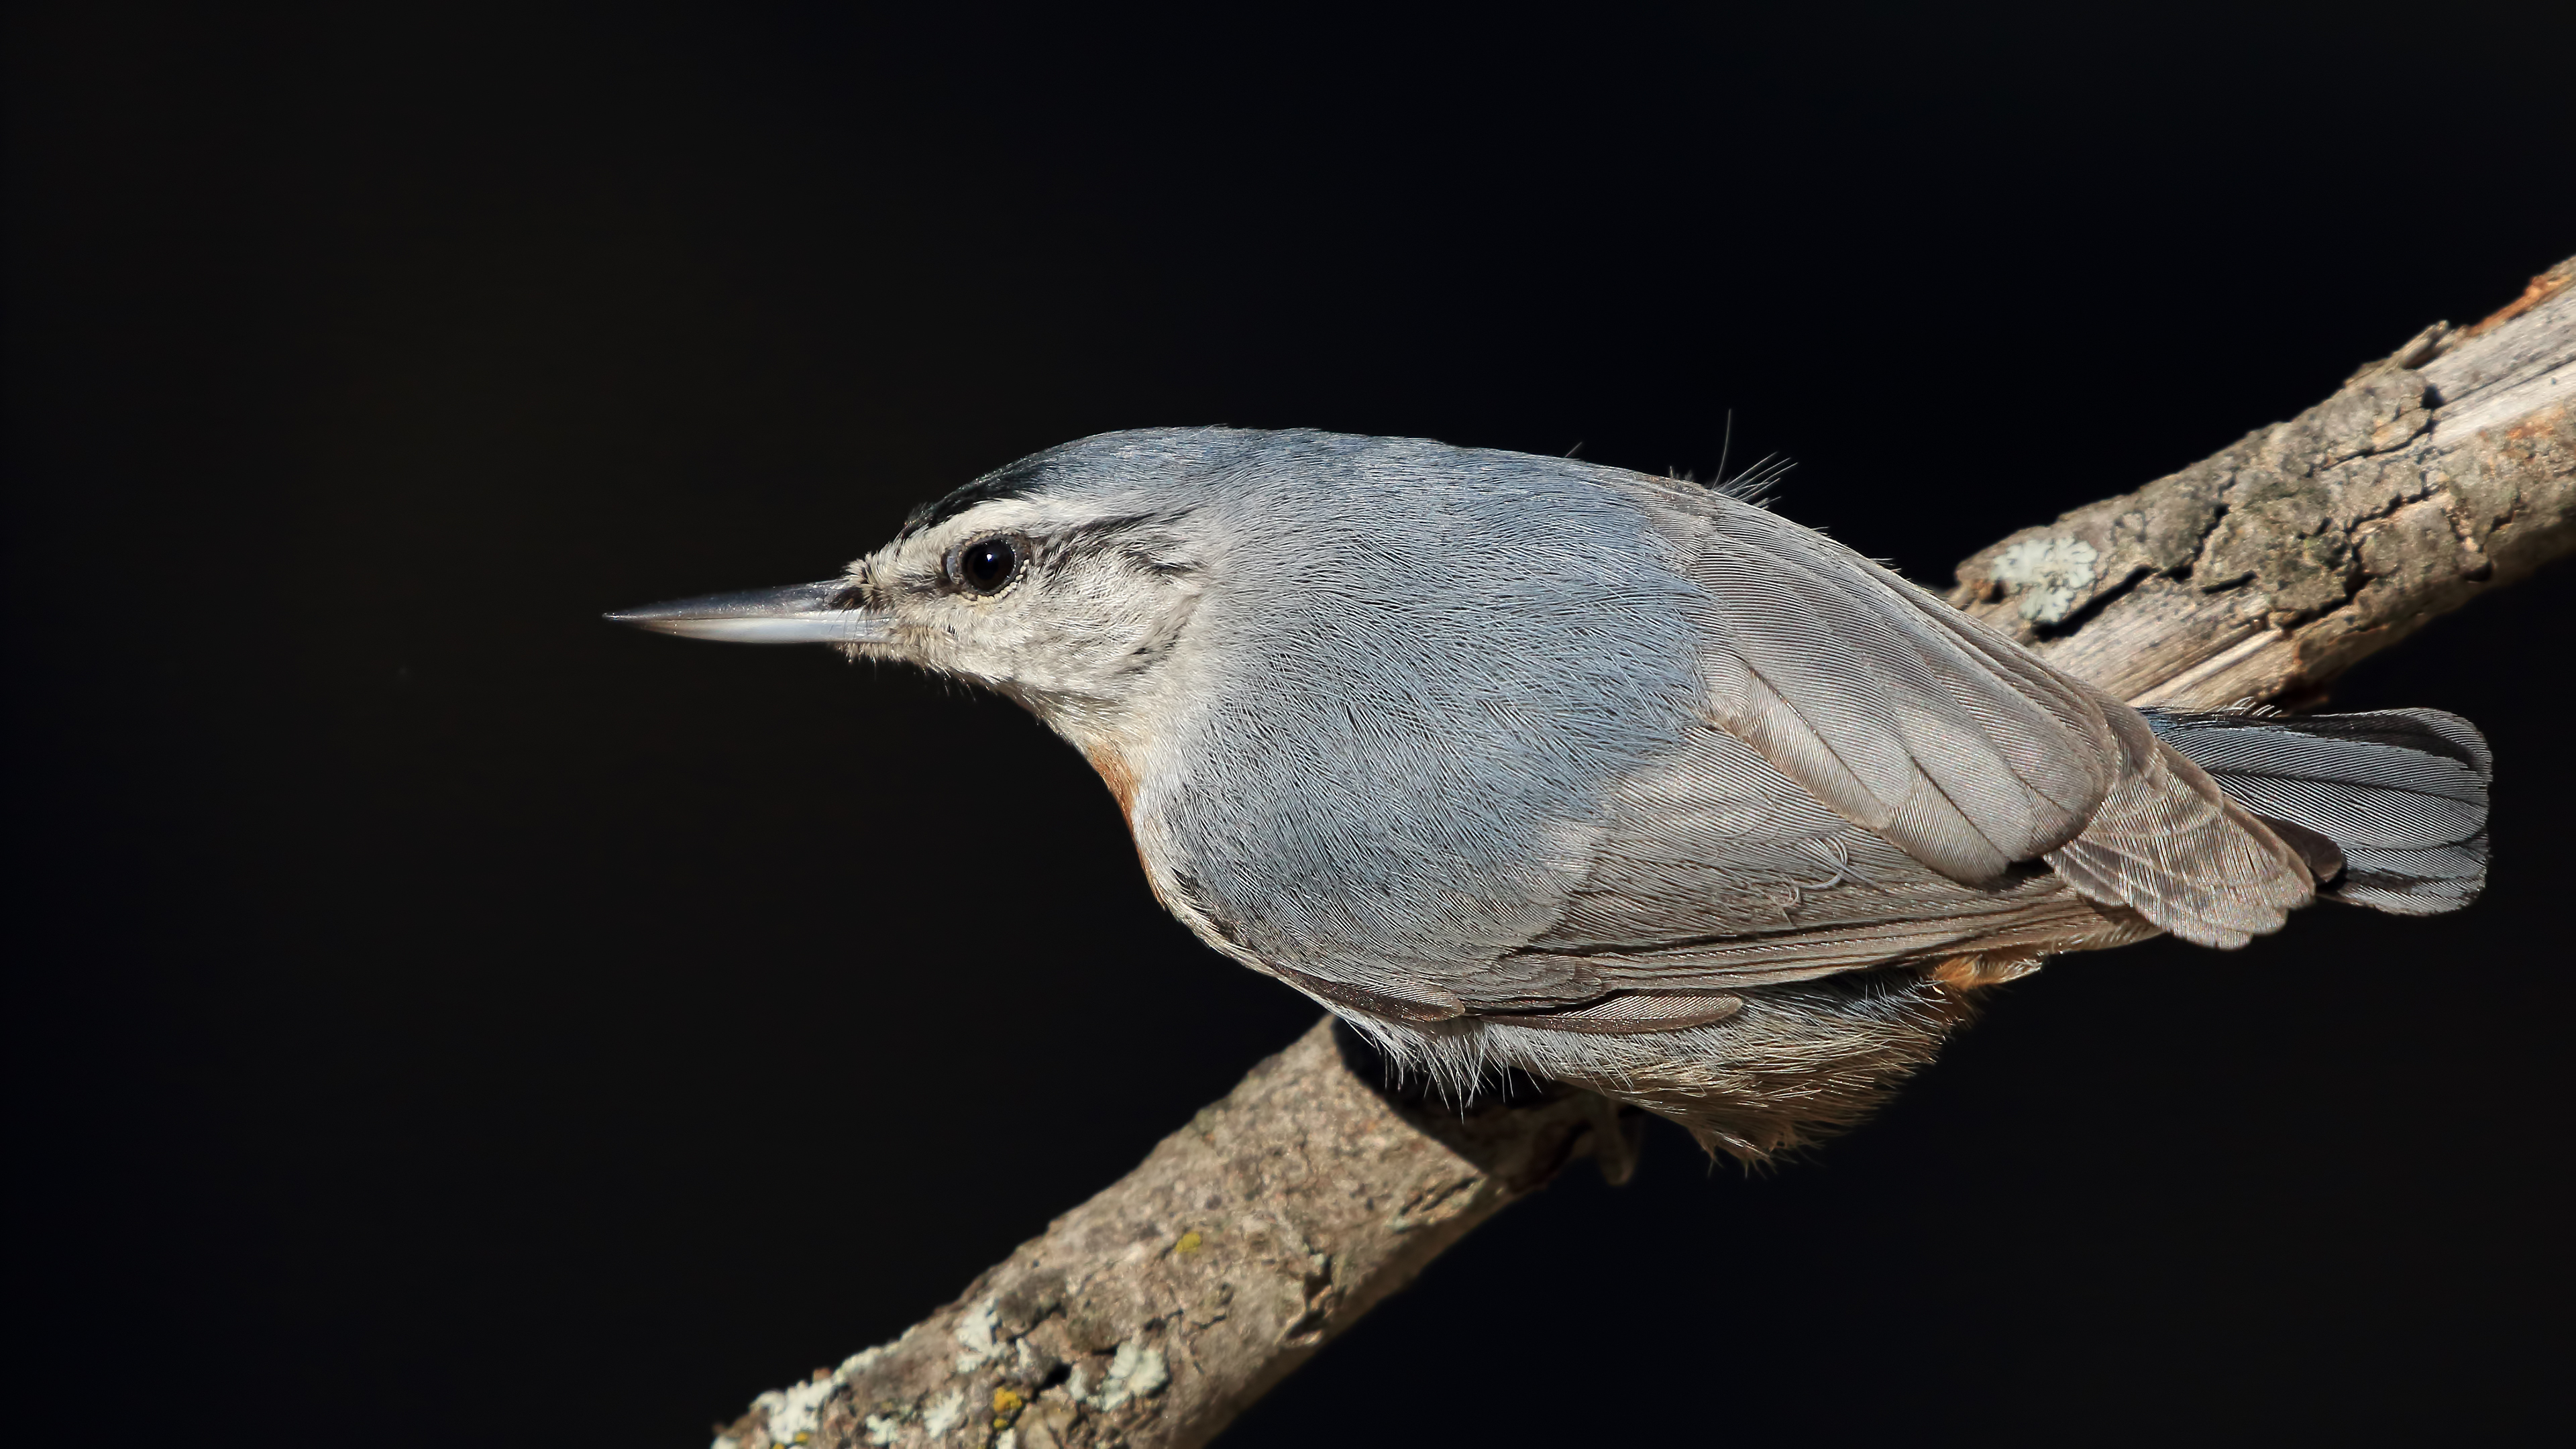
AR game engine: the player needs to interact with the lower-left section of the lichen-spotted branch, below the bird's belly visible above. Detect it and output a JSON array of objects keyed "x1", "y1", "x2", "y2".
[{"x1": 716, "y1": 1018, "x2": 1635, "y2": 1449}]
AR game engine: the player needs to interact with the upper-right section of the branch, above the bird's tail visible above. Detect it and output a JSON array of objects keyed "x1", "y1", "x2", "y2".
[{"x1": 1950, "y1": 260, "x2": 2576, "y2": 706}]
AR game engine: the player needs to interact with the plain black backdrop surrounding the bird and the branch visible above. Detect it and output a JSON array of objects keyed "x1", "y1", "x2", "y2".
[{"x1": 5, "y1": 3, "x2": 2576, "y2": 1446}]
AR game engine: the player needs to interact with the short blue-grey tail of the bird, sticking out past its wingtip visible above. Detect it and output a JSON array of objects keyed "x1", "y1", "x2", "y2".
[{"x1": 2141, "y1": 709, "x2": 2493, "y2": 915}]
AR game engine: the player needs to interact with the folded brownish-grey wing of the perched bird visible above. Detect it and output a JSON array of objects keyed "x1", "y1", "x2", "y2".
[{"x1": 1463, "y1": 474, "x2": 2310, "y2": 1011}]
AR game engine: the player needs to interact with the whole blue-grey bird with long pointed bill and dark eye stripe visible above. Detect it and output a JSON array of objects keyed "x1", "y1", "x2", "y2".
[{"x1": 610, "y1": 428, "x2": 2488, "y2": 1161}]
